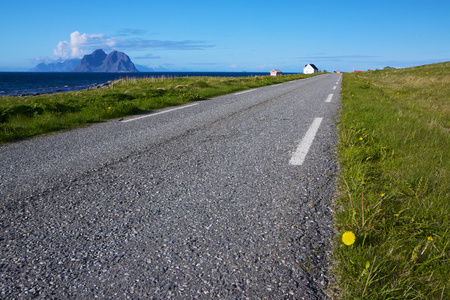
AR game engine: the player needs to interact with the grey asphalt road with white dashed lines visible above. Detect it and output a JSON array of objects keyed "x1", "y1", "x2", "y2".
[{"x1": 0, "y1": 74, "x2": 341, "y2": 299}]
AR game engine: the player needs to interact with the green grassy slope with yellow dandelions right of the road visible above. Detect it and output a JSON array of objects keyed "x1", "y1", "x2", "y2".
[{"x1": 331, "y1": 62, "x2": 450, "y2": 299}]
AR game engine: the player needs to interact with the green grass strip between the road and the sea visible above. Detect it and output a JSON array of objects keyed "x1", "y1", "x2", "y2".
[{"x1": 0, "y1": 74, "x2": 317, "y2": 144}]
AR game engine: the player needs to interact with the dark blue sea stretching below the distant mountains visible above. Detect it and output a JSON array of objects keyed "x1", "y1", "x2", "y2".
[{"x1": 0, "y1": 72, "x2": 276, "y2": 96}]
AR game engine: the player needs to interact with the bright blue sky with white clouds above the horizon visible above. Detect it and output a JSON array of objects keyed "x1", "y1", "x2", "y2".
[{"x1": 0, "y1": 0, "x2": 450, "y2": 72}]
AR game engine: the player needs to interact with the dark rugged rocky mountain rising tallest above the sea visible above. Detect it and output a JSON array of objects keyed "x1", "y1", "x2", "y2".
[{"x1": 72, "y1": 49, "x2": 139, "y2": 73}]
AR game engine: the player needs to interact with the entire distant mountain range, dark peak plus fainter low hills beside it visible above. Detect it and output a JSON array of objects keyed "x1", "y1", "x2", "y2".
[{"x1": 30, "y1": 49, "x2": 139, "y2": 73}]
